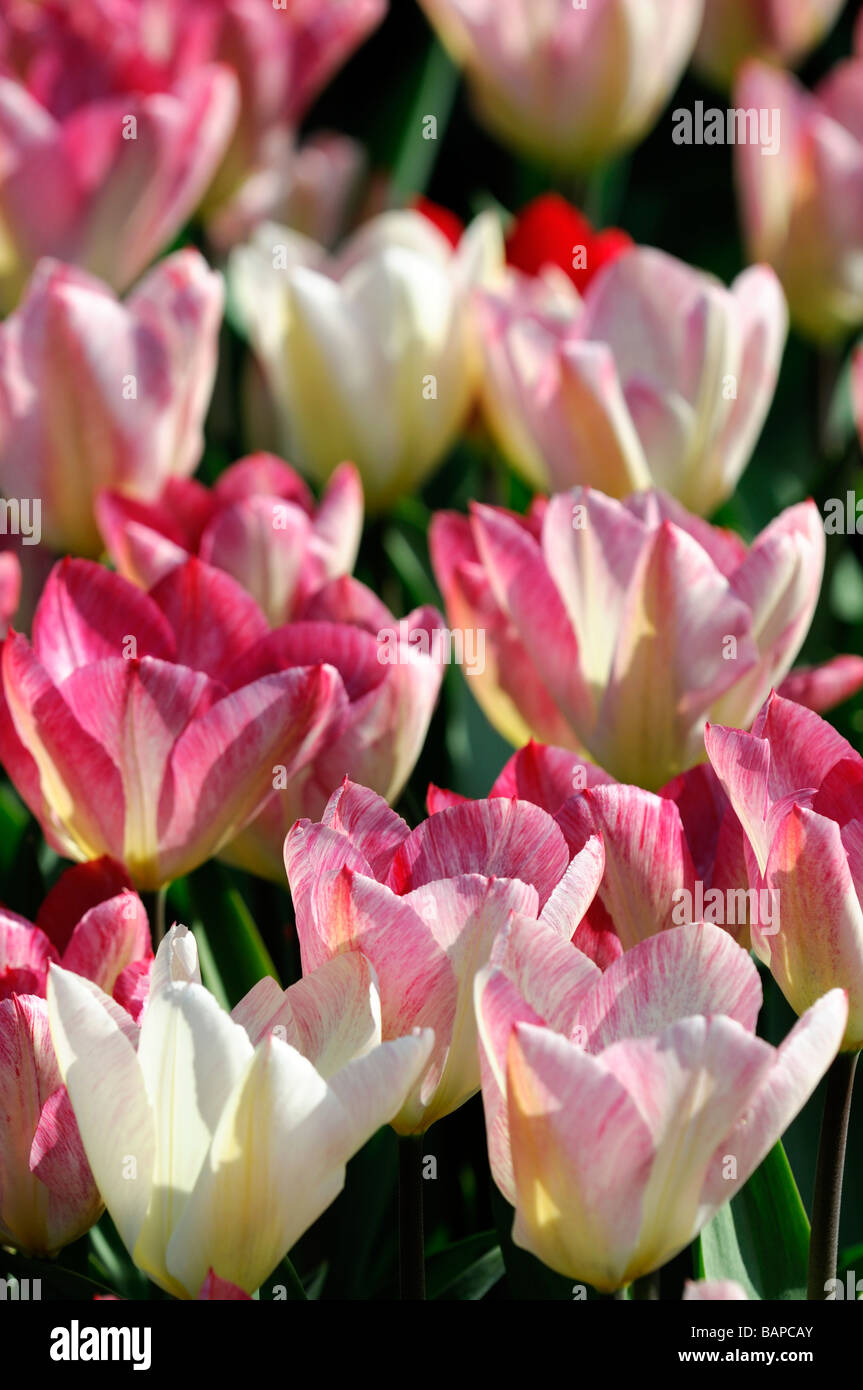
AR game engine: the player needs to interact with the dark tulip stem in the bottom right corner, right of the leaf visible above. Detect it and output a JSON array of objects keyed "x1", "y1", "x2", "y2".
[{"x1": 806, "y1": 1052, "x2": 859, "y2": 1302}]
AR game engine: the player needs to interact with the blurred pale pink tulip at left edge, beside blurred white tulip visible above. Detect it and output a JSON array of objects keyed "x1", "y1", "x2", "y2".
[{"x1": 0, "y1": 250, "x2": 222, "y2": 555}]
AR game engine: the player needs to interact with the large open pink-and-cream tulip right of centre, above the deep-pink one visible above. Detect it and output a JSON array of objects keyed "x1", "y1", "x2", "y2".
[{"x1": 431, "y1": 488, "x2": 863, "y2": 790}]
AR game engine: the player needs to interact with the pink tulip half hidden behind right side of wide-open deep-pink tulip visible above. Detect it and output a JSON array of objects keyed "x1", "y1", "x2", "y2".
[{"x1": 222, "y1": 578, "x2": 449, "y2": 883}]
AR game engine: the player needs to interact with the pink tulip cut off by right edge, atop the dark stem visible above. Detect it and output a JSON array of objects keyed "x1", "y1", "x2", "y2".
[{"x1": 706, "y1": 695, "x2": 863, "y2": 1052}]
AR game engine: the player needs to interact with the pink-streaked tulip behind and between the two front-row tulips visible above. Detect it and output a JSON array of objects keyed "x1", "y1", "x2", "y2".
[{"x1": 285, "y1": 781, "x2": 603, "y2": 1136}]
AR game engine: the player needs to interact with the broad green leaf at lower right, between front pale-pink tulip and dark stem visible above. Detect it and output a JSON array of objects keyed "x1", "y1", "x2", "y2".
[{"x1": 698, "y1": 1143, "x2": 809, "y2": 1300}]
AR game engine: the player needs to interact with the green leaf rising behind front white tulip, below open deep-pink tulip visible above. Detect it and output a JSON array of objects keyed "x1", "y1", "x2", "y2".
[{"x1": 182, "y1": 862, "x2": 278, "y2": 1008}]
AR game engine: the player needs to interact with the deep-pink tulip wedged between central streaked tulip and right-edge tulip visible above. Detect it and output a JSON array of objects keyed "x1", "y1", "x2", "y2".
[{"x1": 428, "y1": 741, "x2": 750, "y2": 969}]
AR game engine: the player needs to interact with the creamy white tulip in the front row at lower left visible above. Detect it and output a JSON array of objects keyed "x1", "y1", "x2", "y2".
[{"x1": 49, "y1": 927, "x2": 432, "y2": 1298}]
